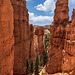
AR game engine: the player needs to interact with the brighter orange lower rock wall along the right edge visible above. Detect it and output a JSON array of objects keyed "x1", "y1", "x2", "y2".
[{"x1": 62, "y1": 19, "x2": 75, "y2": 72}]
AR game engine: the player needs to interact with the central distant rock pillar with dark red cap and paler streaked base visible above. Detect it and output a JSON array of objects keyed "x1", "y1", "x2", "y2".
[{"x1": 34, "y1": 27, "x2": 44, "y2": 55}]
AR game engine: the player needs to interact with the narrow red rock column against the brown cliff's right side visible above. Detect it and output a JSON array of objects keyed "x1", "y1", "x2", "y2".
[{"x1": 28, "y1": 24, "x2": 35, "y2": 61}]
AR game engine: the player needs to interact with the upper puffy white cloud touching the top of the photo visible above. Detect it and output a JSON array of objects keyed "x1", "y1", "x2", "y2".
[{"x1": 35, "y1": 0, "x2": 55, "y2": 13}]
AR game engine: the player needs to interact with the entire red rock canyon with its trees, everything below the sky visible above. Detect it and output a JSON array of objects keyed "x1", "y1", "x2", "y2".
[{"x1": 0, "y1": 0, "x2": 75, "y2": 75}]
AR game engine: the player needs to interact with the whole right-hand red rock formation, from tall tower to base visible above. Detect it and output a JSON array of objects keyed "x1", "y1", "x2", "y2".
[{"x1": 47, "y1": 0, "x2": 75, "y2": 73}]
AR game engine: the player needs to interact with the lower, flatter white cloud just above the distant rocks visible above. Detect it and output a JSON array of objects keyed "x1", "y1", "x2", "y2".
[{"x1": 29, "y1": 13, "x2": 53, "y2": 25}]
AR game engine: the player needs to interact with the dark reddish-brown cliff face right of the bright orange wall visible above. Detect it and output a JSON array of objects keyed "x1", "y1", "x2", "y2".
[{"x1": 11, "y1": 0, "x2": 30, "y2": 75}]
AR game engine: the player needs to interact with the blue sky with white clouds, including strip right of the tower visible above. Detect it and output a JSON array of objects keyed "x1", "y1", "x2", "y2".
[{"x1": 26, "y1": 0, "x2": 75, "y2": 26}]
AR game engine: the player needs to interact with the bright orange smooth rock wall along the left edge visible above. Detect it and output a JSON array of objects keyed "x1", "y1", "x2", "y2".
[{"x1": 0, "y1": 0, "x2": 14, "y2": 75}]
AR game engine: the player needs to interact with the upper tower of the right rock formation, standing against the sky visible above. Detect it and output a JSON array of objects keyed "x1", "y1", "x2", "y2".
[{"x1": 54, "y1": 0, "x2": 69, "y2": 26}]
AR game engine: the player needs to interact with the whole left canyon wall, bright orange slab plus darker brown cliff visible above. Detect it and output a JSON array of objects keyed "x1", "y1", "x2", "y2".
[{"x1": 0, "y1": 0, "x2": 35, "y2": 75}]
